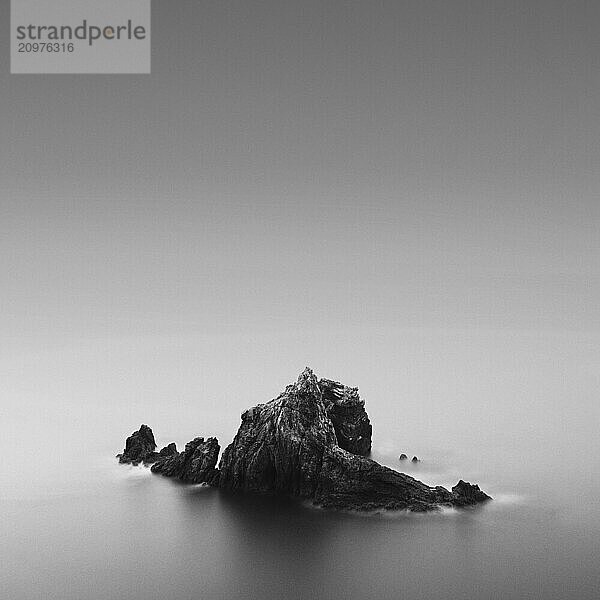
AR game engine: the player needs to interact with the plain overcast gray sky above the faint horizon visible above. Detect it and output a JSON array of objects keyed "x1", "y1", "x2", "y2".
[{"x1": 0, "y1": 0, "x2": 600, "y2": 344}]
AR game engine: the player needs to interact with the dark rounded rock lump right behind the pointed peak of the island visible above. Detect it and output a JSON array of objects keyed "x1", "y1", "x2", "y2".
[{"x1": 319, "y1": 379, "x2": 373, "y2": 456}]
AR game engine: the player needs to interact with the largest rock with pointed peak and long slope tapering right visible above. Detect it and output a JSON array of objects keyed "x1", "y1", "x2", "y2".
[{"x1": 219, "y1": 368, "x2": 488, "y2": 511}]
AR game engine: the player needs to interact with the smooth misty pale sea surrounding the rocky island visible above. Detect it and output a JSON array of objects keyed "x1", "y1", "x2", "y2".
[{"x1": 0, "y1": 330, "x2": 600, "y2": 600}]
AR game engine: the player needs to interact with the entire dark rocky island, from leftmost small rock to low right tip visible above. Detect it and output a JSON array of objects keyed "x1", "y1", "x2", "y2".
[{"x1": 117, "y1": 368, "x2": 490, "y2": 512}]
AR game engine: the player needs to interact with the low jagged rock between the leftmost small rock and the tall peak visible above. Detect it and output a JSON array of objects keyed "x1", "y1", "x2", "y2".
[{"x1": 151, "y1": 438, "x2": 221, "y2": 483}]
